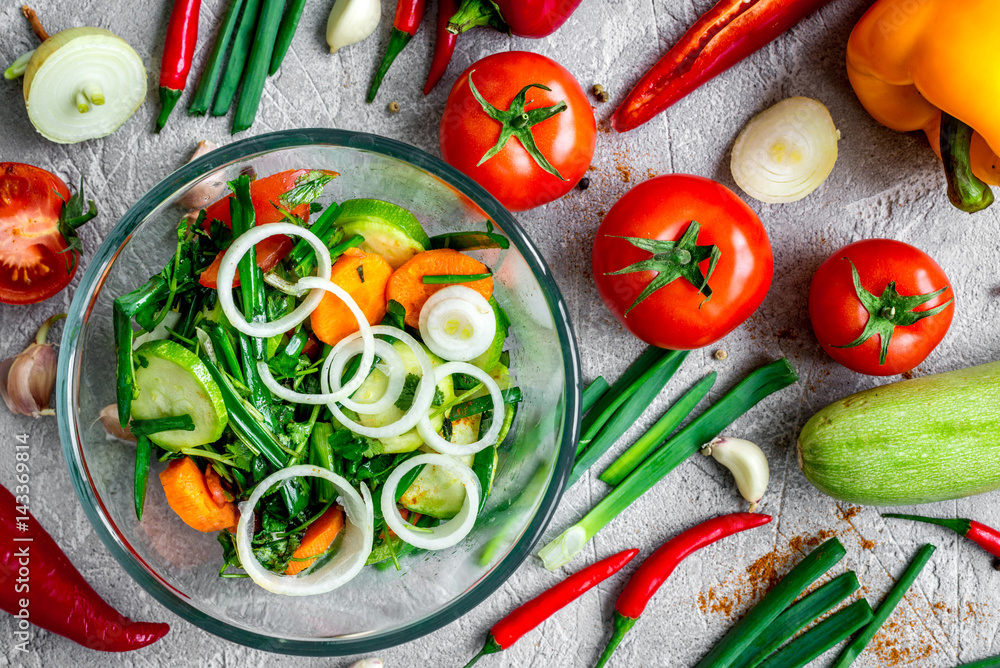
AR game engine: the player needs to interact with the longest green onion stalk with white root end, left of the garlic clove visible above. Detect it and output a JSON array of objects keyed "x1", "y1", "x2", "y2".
[{"x1": 538, "y1": 358, "x2": 798, "y2": 570}]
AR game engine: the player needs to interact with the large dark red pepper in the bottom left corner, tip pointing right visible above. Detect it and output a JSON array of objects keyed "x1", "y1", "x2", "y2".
[{"x1": 0, "y1": 485, "x2": 170, "y2": 652}]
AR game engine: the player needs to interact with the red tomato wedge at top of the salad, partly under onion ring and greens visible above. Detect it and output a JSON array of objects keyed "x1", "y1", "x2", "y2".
[{"x1": 198, "y1": 169, "x2": 309, "y2": 289}]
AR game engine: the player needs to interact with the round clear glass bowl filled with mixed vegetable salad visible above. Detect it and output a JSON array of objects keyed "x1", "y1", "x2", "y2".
[{"x1": 56, "y1": 130, "x2": 580, "y2": 655}]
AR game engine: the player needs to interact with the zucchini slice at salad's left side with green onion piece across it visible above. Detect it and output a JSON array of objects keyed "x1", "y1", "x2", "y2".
[{"x1": 132, "y1": 340, "x2": 229, "y2": 452}]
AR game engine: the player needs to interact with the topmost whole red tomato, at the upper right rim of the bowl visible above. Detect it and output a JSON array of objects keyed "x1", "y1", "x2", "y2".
[{"x1": 440, "y1": 51, "x2": 597, "y2": 211}]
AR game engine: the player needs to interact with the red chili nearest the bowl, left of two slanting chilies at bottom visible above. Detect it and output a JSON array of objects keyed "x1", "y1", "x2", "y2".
[{"x1": 465, "y1": 549, "x2": 639, "y2": 668}]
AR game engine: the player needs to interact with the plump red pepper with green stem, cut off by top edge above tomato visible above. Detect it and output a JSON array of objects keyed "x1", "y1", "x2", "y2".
[{"x1": 448, "y1": 0, "x2": 580, "y2": 39}]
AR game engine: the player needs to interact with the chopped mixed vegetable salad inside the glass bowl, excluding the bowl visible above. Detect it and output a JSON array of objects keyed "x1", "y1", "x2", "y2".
[{"x1": 113, "y1": 169, "x2": 521, "y2": 595}]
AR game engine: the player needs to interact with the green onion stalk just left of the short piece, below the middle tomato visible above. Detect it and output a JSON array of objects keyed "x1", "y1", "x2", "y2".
[{"x1": 566, "y1": 350, "x2": 688, "y2": 488}]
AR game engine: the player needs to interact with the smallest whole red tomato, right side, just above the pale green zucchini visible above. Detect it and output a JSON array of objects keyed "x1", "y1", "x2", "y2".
[{"x1": 809, "y1": 239, "x2": 955, "y2": 376}]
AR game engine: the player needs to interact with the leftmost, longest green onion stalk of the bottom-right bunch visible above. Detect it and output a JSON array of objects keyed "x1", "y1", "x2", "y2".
[{"x1": 695, "y1": 536, "x2": 847, "y2": 668}]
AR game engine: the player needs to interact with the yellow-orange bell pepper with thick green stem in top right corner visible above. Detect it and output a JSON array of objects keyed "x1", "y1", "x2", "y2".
[{"x1": 847, "y1": 0, "x2": 1000, "y2": 212}]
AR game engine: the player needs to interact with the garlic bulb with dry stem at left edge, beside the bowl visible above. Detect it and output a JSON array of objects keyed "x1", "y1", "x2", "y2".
[{"x1": 0, "y1": 313, "x2": 66, "y2": 418}]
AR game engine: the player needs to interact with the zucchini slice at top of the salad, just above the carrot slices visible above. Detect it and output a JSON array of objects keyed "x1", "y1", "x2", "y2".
[{"x1": 337, "y1": 199, "x2": 431, "y2": 269}]
